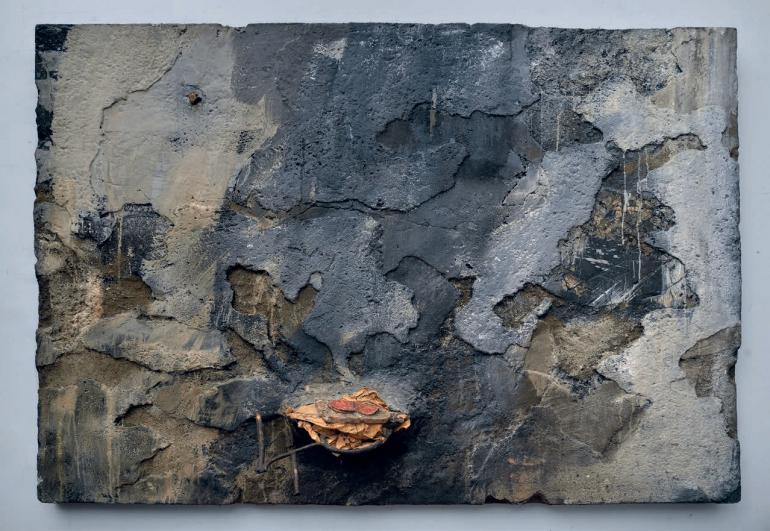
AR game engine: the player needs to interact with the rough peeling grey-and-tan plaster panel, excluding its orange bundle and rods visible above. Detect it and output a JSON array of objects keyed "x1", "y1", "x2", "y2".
[{"x1": 34, "y1": 24, "x2": 740, "y2": 505}]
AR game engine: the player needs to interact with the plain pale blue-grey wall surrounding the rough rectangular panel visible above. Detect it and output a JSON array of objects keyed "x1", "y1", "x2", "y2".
[{"x1": 0, "y1": 0, "x2": 770, "y2": 531}]
